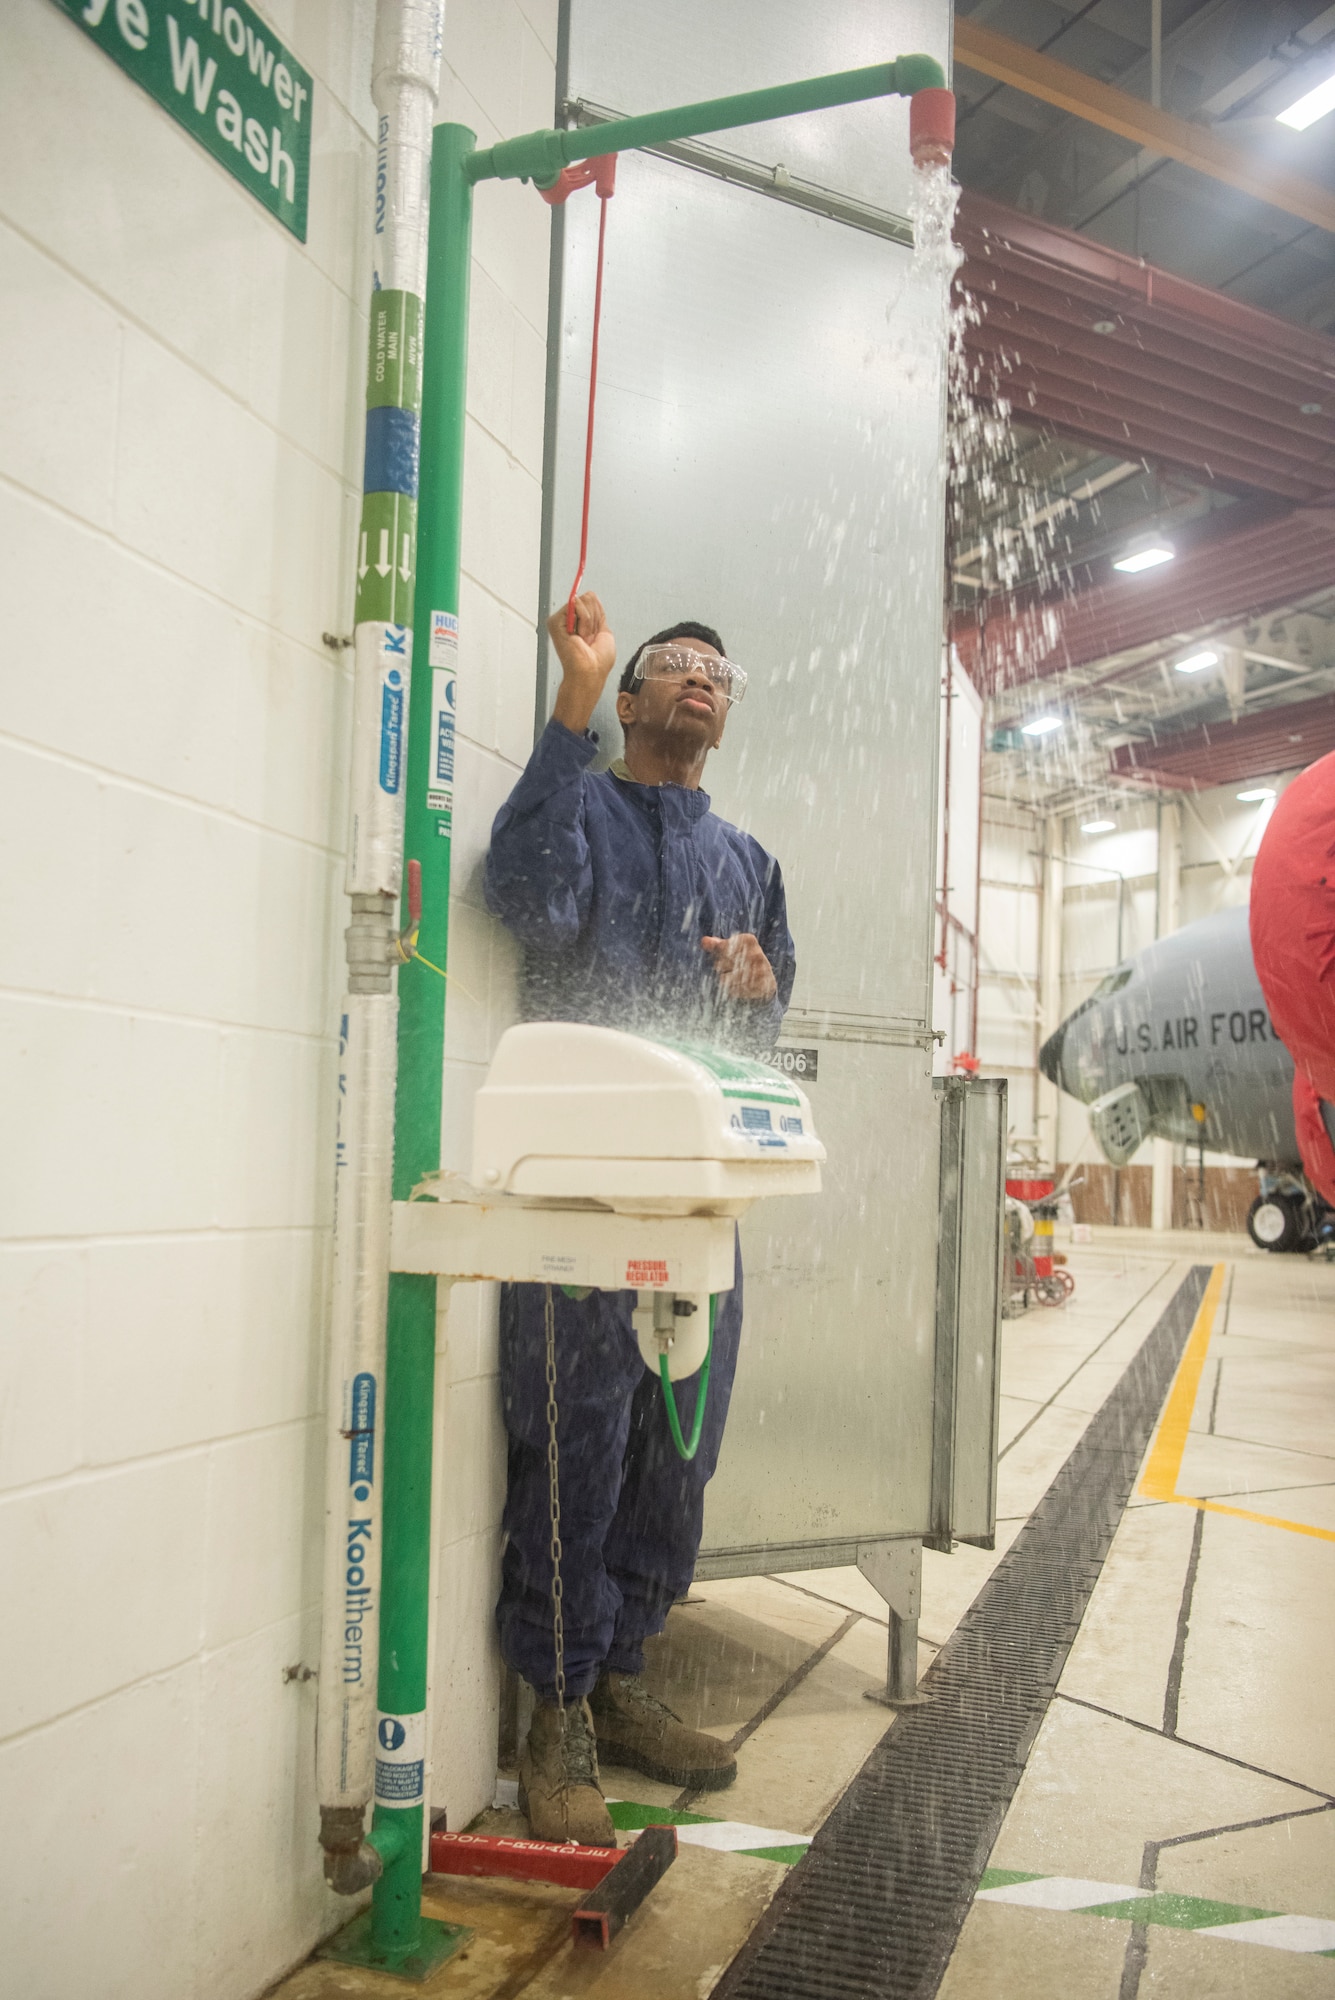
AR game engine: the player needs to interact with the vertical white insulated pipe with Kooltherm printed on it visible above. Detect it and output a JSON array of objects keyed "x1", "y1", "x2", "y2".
[{"x1": 316, "y1": 0, "x2": 444, "y2": 1864}]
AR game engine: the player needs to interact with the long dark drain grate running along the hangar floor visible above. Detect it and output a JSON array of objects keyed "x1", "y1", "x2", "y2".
[{"x1": 715, "y1": 1264, "x2": 1211, "y2": 2000}]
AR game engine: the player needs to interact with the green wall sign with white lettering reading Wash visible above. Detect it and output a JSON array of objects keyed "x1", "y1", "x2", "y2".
[{"x1": 56, "y1": 0, "x2": 312, "y2": 242}]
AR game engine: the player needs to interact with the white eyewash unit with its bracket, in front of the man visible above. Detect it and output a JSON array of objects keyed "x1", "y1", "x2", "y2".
[{"x1": 390, "y1": 1022, "x2": 825, "y2": 1380}]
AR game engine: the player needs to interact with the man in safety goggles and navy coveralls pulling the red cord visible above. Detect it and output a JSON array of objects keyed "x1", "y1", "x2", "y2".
[{"x1": 486, "y1": 594, "x2": 793, "y2": 1846}]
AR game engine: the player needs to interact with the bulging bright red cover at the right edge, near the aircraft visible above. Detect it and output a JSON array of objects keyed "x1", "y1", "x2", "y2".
[{"x1": 1251, "y1": 752, "x2": 1335, "y2": 1204}]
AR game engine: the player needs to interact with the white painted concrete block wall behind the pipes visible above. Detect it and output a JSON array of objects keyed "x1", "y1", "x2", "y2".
[{"x1": 0, "y1": 0, "x2": 556, "y2": 2000}]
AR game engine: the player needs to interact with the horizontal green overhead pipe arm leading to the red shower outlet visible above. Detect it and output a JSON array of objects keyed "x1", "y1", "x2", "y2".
[{"x1": 464, "y1": 56, "x2": 945, "y2": 188}]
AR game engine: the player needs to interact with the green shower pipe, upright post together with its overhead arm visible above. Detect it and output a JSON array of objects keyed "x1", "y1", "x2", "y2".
[{"x1": 360, "y1": 56, "x2": 945, "y2": 1978}]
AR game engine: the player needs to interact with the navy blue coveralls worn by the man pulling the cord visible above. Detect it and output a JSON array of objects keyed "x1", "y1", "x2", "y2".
[{"x1": 486, "y1": 722, "x2": 795, "y2": 1700}]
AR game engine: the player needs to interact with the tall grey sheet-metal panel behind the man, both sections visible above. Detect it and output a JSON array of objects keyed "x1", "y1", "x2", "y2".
[{"x1": 548, "y1": 0, "x2": 949, "y2": 1574}]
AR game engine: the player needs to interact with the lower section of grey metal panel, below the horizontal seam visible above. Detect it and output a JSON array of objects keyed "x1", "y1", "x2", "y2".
[{"x1": 699, "y1": 1042, "x2": 937, "y2": 1576}]
